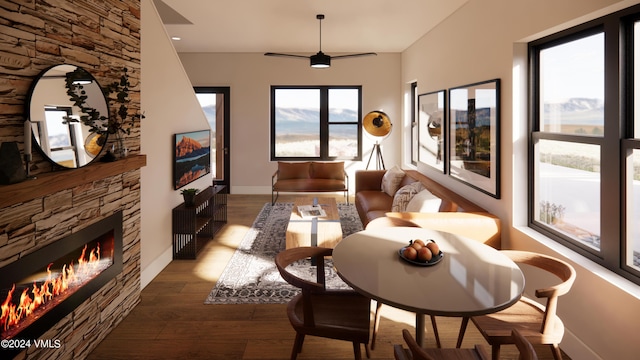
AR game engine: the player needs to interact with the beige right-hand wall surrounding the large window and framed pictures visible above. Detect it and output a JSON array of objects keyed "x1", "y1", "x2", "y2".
[{"x1": 402, "y1": 0, "x2": 640, "y2": 359}]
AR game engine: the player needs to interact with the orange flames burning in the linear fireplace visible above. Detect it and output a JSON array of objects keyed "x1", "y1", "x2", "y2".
[{"x1": 0, "y1": 244, "x2": 100, "y2": 331}]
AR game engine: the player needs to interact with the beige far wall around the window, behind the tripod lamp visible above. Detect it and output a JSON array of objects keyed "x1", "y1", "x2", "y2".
[{"x1": 180, "y1": 53, "x2": 402, "y2": 194}]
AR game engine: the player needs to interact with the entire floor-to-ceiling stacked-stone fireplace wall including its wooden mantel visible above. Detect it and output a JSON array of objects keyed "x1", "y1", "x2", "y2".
[{"x1": 0, "y1": 0, "x2": 146, "y2": 359}]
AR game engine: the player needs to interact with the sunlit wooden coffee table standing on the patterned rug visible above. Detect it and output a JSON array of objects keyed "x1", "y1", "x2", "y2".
[{"x1": 286, "y1": 196, "x2": 342, "y2": 249}]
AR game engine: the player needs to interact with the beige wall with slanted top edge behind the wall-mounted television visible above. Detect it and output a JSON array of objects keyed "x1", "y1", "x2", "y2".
[{"x1": 140, "y1": 0, "x2": 211, "y2": 288}]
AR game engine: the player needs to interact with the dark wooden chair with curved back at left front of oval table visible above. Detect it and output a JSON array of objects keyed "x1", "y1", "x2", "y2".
[{"x1": 275, "y1": 247, "x2": 371, "y2": 360}]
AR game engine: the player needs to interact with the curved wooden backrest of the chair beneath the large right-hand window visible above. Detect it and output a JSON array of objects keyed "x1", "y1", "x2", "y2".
[{"x1": 502, "y1": 250, "x2": 576, "y2": 334}]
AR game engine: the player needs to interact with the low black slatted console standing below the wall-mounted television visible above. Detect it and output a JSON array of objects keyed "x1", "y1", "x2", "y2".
[{"x1": 173, "y1": 185, "x2": 227, "y2": 259}]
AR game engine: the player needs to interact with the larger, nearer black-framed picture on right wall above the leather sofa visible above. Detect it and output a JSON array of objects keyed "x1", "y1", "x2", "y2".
[{"x1": 448, "y1": 79, "x2": 500, "y2": 199}]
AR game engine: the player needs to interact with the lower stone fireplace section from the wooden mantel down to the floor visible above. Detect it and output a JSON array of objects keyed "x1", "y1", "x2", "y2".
[{"x1": 0, "y1": 155, "x2": 146, "y2": 359}]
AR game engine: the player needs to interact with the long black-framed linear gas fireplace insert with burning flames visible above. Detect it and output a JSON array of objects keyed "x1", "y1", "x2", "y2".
[{"x1": 0, "y1": 211, "x2": 122, "y2": 358}]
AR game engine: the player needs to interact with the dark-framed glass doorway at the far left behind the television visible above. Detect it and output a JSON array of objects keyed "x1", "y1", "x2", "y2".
[{"x1": 193, "y1": 86, "x2": 231, "y2": 192}]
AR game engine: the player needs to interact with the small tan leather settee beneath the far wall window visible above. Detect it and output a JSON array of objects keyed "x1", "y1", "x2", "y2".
[{"x1": 271, "y1": 161, "x2": 349, "y2": 204}]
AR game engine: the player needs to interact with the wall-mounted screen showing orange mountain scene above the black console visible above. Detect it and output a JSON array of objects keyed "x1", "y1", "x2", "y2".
[{"x1": 173, "y1": 130, "x2": 211, "y2": 190}]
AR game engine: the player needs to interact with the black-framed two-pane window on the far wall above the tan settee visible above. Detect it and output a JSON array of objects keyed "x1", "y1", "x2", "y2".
[{"x1": 271, "y1": 86, "x2": 362, "y2": 160}]
